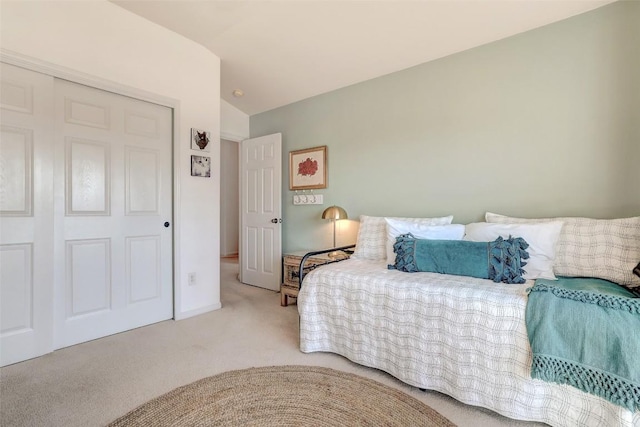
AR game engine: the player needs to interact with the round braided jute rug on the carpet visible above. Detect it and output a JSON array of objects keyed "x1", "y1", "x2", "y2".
[{"x1": 110, "y1": 366, "x2": 455, "y2": 427}]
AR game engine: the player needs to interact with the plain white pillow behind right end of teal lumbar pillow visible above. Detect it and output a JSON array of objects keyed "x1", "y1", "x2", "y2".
[{"x1": 464, "y1": 221, "x2": 562, "y2": 280}]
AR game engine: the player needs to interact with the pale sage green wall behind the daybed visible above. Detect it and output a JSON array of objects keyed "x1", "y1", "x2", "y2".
[{"x1": 250, "y1": 2, "x2": 640, "y2": 251}]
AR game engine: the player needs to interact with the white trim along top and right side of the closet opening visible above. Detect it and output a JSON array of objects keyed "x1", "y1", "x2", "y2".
[{"x1": 0, "y1": 49, "x2": 182, "y2": 320}]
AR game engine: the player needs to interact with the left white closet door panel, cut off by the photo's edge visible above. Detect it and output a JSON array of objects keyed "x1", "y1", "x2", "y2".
[{"x1": 0, "y1": 63, "x2": 53, "y2": 366}]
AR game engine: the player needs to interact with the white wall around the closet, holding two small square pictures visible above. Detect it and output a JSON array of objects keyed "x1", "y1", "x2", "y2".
[{"x1": 0, "y1": 0, "x2": 222, "y2": 319}]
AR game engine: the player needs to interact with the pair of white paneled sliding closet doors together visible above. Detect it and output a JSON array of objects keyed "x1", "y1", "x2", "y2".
[{"x1": 0, "y1": 64, "x2": 173, "y2": 366}]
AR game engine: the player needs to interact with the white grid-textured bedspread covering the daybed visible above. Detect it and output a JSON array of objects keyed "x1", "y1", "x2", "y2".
[{"x1": 298, "y1": 259, "x2": 640, "y2": 427}]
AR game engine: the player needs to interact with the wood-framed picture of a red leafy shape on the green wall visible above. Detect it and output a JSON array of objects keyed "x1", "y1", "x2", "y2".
[{"x1": 289, "y1": 145, "x2": 327, "y2": 190}]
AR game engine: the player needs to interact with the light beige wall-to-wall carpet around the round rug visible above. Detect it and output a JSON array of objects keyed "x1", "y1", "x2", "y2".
[{"x1": 0, "y1": 259, "x2": 540, "y2": 427}]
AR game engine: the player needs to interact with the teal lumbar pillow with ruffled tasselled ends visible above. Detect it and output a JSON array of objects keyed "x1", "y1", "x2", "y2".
[{"x1": 389, "y1": 234, "x2": 529, "y2": 283}]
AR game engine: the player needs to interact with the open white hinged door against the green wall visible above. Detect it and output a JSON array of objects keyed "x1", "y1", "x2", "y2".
[{"x1": 240, "y1": 133, "x2": 282, "y2": 291}]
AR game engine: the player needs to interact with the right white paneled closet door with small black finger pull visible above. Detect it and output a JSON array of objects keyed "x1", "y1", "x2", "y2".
[{"x1": 54, "y1": 80, "x2": 173, "y2": 348}]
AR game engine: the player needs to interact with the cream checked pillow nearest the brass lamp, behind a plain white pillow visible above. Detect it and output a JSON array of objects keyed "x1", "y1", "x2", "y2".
[{"x1": 352, "y1": 215, "x2": 453, "y2": 261}]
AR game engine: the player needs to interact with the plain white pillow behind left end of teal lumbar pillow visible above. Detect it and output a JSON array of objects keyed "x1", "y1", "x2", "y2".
[{"x1": 385, "y1": 218, "x2": 464, "y2": 264}]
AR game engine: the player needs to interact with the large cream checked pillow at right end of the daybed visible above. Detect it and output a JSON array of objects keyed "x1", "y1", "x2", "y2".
[{"x1": 486, "y1": 212, "x2": 640, "y2": 292}]
